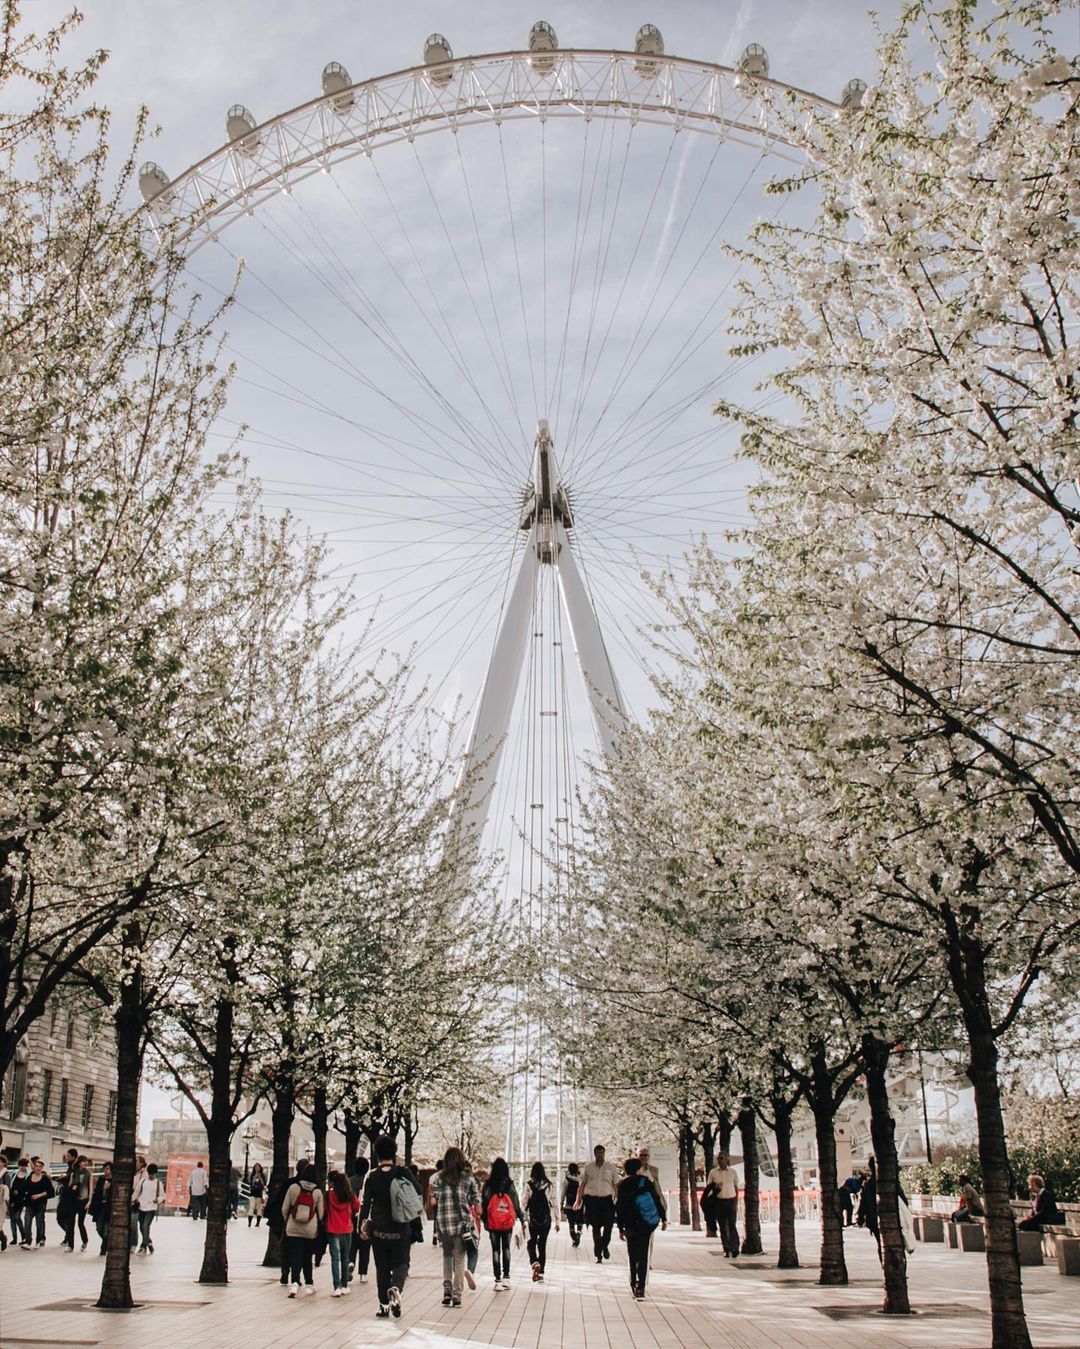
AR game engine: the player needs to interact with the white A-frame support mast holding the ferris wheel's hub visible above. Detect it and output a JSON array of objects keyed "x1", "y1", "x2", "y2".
[{"x1": 458, "y1": 421, "x2": 626, "y2": 842}]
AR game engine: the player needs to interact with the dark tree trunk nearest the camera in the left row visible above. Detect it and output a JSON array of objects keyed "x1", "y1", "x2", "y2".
[{"x1": 94, "y1": 919, "x2": 143, "y2": 1311}]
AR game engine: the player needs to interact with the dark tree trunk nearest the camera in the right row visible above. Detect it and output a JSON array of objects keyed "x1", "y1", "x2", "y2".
[{"x1": 964, "y1": 1014, "x2": 1031, "y2": 1349}]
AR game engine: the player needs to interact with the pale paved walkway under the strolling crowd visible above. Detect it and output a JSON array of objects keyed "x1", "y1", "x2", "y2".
[{"x1": 0, "y1": 1218, "x2": 1080, "y2": 1349}]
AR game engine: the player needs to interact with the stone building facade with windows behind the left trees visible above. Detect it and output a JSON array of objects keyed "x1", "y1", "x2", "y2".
[{"x1": 0, "y1": 1000, "x2": 116, "y2": 1164}]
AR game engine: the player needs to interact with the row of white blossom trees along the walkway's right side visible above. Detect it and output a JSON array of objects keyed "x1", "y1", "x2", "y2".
[{"x1": 568, "y1": 0, "x2": 1080, "y2": 1349}]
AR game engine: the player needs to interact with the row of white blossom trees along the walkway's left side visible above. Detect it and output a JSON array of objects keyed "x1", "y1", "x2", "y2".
[{"x1": 0, "y1": 0, "x2": 496, "y2": 1307}]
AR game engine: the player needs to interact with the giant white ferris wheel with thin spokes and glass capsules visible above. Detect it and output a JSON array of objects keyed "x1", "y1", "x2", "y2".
[{"x1": 139, "y1": 22, "x2": 866, "y2": 1161}]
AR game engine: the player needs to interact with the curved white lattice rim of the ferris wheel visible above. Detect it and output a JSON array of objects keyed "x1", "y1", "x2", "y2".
[{"x1": 143, "y1": 49, "x2": 841, "y2": 255}]
